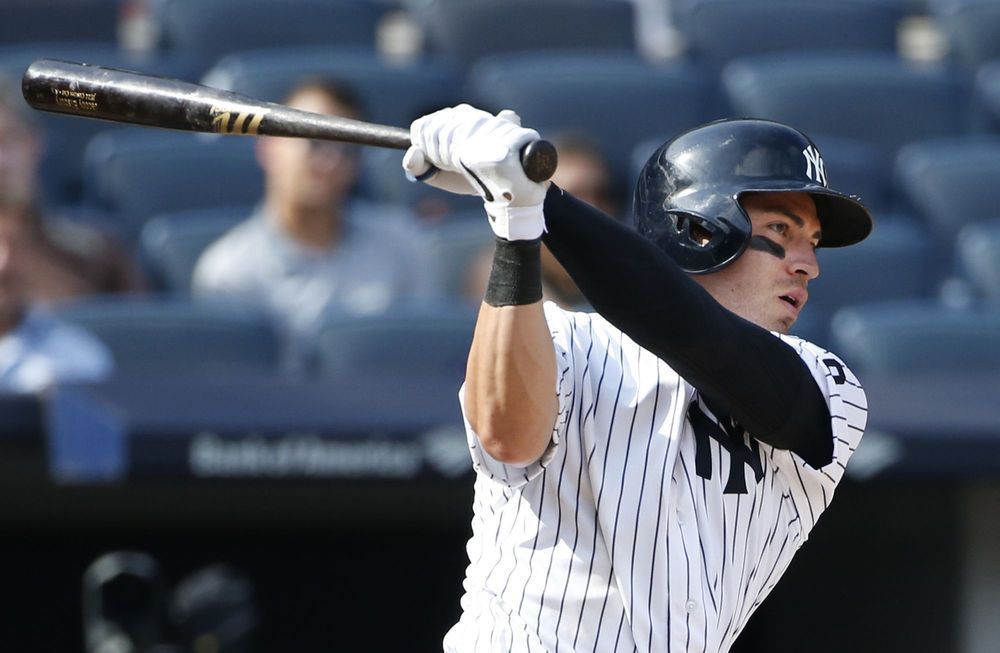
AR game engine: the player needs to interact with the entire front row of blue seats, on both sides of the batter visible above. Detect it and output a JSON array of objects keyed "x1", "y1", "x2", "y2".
[{"x1": 50, "y1": 298, "x2": 1000, "y2": 384}]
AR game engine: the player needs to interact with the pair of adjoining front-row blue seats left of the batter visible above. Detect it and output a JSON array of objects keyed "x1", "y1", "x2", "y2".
[{"x1": 55, "y1": 296, "x2": 475, "y2": 381}]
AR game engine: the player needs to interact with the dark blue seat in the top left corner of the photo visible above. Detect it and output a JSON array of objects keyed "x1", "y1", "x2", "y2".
[{"x1": 0, "y1": 0, "x2": 121, "y2": 44}]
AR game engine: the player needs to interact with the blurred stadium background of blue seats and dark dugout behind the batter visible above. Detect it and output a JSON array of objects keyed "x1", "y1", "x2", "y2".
[{"x1": 0, "y1": 0, "x2": 1000, "y2": 653}]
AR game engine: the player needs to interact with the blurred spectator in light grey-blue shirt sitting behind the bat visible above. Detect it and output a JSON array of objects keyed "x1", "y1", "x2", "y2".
[{"x1": 192, "y1": 80, "x2": 425, "y2": 360}]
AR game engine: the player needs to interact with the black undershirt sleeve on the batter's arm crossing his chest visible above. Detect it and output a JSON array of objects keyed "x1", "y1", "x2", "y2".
[{"x1": 543, "y1": 184, "x2": 833, "y2": 468}]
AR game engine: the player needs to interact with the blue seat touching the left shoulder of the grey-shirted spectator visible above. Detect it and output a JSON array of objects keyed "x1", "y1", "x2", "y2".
[{"x1": 139, "y1": 206, "x2": 253, "y2": 295}]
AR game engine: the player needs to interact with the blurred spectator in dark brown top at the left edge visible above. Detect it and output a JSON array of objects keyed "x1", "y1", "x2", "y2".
[{"x1": 0, "y1": 79, "x2": 143, "y2": 302}]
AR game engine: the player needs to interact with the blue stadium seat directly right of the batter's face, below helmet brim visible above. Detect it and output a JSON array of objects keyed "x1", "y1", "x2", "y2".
[{"x1": 793, "y1": 215, "x2": 945, "y2": 345}]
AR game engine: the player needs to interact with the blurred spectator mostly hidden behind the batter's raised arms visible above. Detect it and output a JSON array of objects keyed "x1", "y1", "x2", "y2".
[{"x1": 465, "y1": 134, "x2": 619, "y2": 309}]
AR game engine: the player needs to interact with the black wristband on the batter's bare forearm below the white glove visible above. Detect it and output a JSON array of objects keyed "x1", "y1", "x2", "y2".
[{"x1": 484, "y1": 237, "x2": 542, "y2": 306}]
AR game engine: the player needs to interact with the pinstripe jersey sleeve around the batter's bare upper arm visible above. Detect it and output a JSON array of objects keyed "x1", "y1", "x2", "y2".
[{"x1": 458, "y1": 302, "x2": 575, "y2": 488}]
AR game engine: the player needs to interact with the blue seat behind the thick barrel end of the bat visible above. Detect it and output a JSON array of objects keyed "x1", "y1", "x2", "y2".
[{"x1": 0, "y1": 46, "x2": 204, "y2": 205}]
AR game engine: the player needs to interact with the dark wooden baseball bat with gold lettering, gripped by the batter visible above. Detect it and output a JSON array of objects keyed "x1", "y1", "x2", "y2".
[{"x1": 21, "y1": 59, "x2": 556, "y2": 182}]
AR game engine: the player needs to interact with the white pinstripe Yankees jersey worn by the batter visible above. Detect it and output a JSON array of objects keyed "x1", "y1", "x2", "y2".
[{"x1": 444, "y1": 303, "x2": 867, "y2": 653}]
